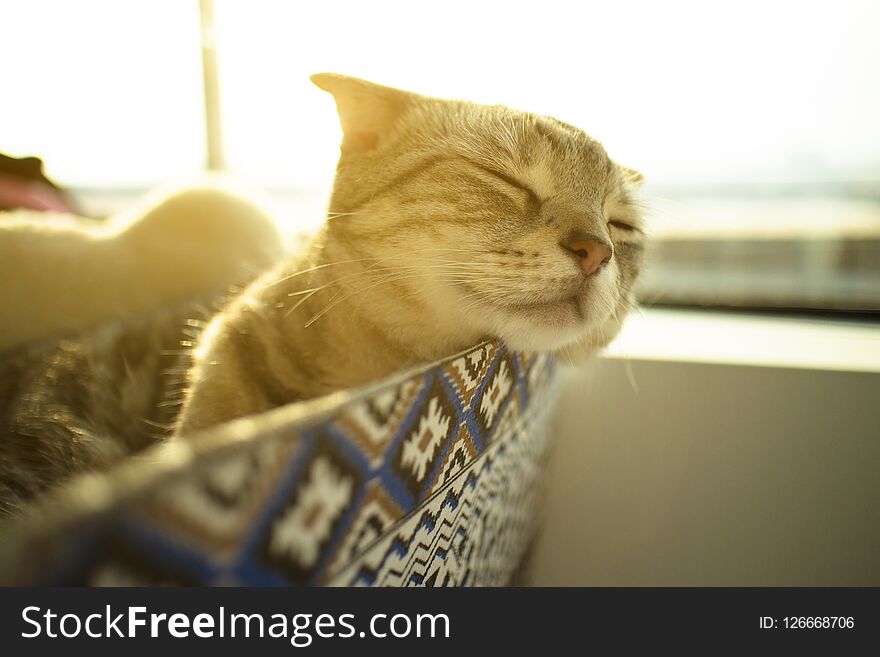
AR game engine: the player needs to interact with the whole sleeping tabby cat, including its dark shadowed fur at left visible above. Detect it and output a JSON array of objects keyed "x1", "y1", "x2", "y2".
[{"x1": 0, "y1": 73, "x2": 644, "y2": 513}]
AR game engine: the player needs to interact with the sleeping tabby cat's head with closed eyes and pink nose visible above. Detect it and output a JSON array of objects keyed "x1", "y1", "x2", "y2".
[{"x1": 312, "y1": 73, "x2": 644, "y2": 351}]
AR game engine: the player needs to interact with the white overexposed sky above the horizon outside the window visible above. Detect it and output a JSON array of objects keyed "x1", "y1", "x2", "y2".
[{"x1": 0, "y1": 0, "x2": 880, "y2": 190}]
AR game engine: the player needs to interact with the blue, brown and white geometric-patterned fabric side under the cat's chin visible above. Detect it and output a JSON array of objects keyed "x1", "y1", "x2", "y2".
[{"x1": 0, "y1": 343, "x2": 558, "y2": 586}]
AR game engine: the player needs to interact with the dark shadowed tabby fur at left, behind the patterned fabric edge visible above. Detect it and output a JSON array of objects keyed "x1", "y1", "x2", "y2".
[{"x1": 0, "y1": 302, "x2": 210, "y2": 516}]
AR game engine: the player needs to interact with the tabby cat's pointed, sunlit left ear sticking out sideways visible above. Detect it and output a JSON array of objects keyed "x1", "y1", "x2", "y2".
[{"x1": 311, "y1": 73, "x2": 415, "y2": 151}]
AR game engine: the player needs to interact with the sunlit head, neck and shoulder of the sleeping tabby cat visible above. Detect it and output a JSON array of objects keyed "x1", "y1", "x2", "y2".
[{"x1": 177, "y1": 73, "x2": 644, "y2": 434}]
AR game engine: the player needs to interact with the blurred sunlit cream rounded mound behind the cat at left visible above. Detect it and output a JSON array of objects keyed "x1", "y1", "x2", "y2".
[{"x1": 0, "y1": 183, "x2": 282, "y2": 351}]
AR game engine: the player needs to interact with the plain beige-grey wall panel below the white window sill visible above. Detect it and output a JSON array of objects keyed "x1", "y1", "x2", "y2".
[{"x1": 529, "y1": 348, "x2": 880, "y2": 586}]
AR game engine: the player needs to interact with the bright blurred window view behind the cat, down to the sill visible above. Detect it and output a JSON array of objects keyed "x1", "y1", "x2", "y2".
[{"x1": 0, "y1": 0, "x2": 880, "y2": 312}]
